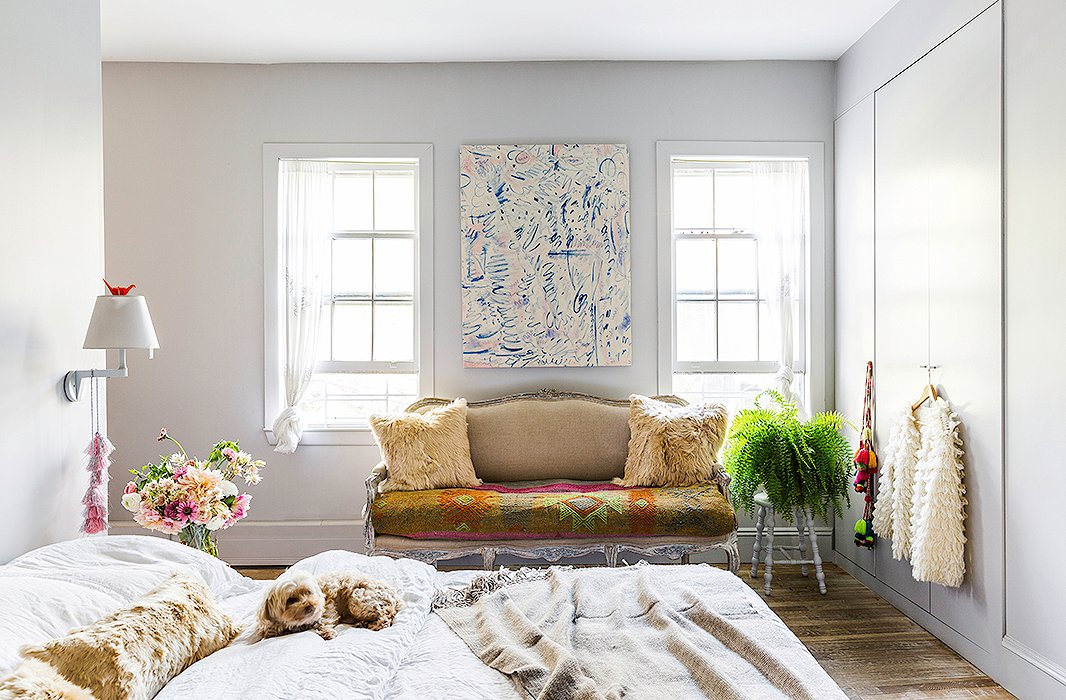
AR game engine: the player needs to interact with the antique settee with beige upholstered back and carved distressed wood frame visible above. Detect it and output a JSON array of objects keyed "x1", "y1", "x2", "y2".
[{"x1": 364, "y1": 389, "x2": 739, "y2": 572}]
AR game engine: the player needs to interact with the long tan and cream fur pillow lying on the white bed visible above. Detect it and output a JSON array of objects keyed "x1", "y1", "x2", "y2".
[{"x1": 12, "y1": 572, "x2": 240, "y2": 700}]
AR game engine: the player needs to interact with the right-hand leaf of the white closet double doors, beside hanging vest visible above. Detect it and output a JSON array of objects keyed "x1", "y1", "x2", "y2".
[{"x1": 919, "y1": 5, "x2": 1003, "y2": 649}]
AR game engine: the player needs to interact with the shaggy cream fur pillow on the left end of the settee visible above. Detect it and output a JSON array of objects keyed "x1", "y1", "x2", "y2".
[{"x1": 370, "y1": 398, "x2": 481, "y2": 491}]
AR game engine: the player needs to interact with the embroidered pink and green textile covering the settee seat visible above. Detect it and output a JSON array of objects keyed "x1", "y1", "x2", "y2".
[{"x1": 371, "y1": 482, "x2": 736, "y2": 540}]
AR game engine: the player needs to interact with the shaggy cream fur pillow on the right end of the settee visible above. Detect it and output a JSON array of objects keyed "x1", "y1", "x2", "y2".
[{"x1": 614, "y1": 394, "x2": 729, "y2": 487}]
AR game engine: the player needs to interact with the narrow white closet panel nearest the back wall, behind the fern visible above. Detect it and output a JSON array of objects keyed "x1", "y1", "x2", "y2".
[{"x1": 835, "y1": 95, "x2": 876, "y2": 574}]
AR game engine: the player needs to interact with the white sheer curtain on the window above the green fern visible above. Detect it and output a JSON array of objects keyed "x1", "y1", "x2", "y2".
[{"x1": 752, "y1": 161, "x2": 810, "y2": 414}]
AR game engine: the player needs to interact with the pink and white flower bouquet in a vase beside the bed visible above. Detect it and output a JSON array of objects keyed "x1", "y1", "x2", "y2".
[{"x1": 123, "y1": 428, "x2": 267, "y2": 556}]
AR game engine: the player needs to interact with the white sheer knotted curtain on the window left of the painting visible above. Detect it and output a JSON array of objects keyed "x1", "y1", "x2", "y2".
[{"x1": 274, "y1": 160, "x2": 333, "y2": 453}]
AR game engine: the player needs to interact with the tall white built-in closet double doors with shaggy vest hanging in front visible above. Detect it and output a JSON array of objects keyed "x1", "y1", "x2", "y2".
[{"x1": 875, "y1": 5, "x2": 1003, "y2": 649}]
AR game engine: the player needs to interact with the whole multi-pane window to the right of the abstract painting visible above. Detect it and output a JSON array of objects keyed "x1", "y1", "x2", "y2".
[{"x1": 659, "y1": 142, "x2": 821, "y2": 411}]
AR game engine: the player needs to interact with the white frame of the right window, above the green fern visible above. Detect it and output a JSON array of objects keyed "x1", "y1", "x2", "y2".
[{"x1": 656, "y1": 141, "x2": 831, "y2": 410}]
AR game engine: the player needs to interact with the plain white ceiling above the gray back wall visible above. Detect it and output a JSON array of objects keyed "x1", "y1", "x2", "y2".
[{"x1": 101, "y1": 0, "x2": 898, "y2": 63}]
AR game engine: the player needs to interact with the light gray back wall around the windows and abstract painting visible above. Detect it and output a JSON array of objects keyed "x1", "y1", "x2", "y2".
[{"x1": 103, "y1": 62, "x2": 834, "y2": 556}]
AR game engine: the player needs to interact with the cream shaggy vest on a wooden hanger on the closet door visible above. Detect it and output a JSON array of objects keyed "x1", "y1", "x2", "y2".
[{"x1": 873, "y1": 398, "x2": 966, "y2": 587}]
